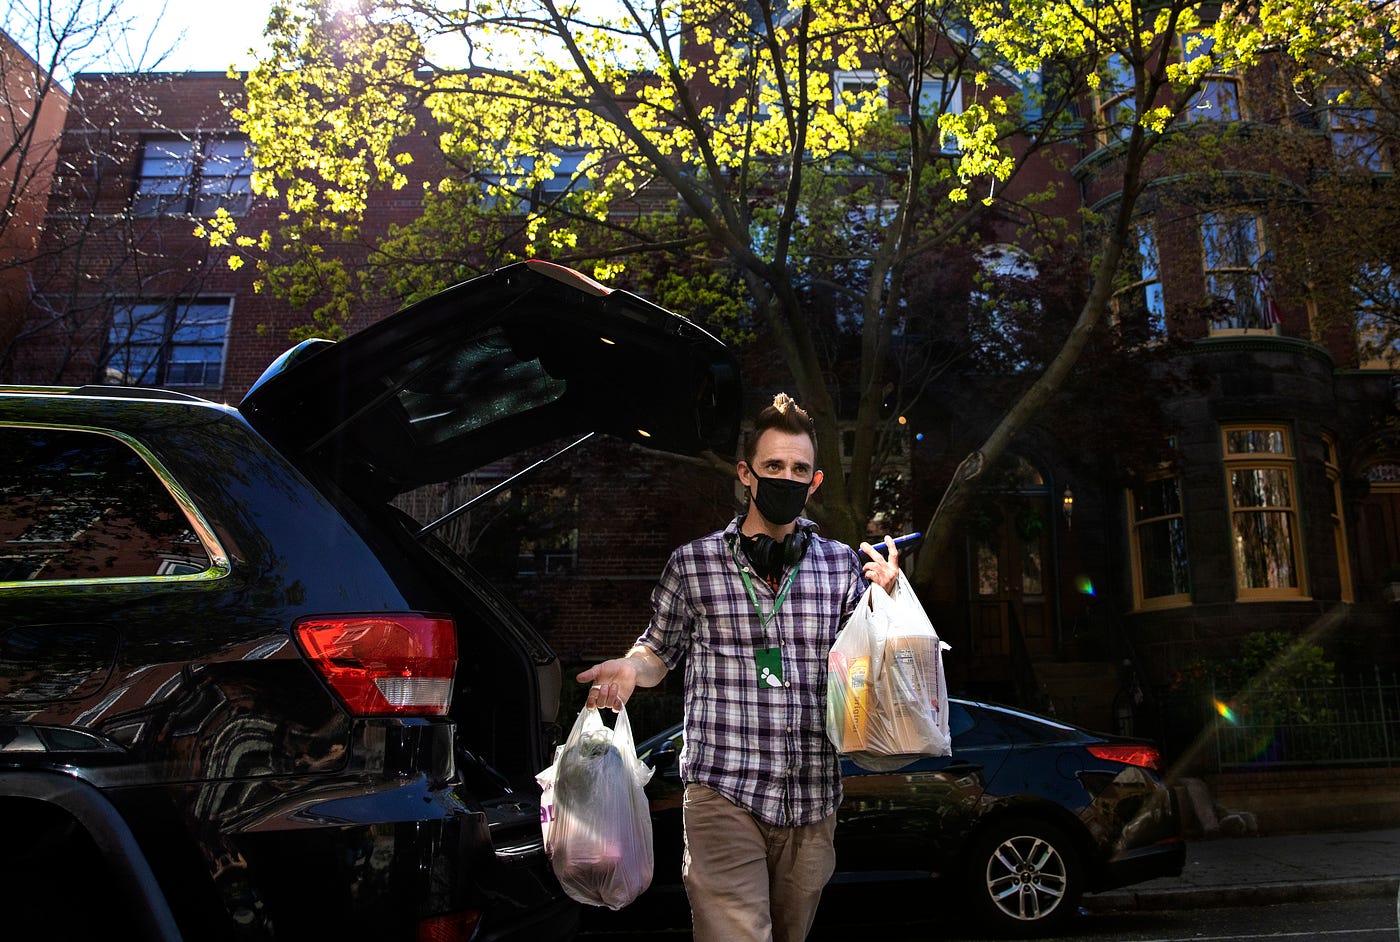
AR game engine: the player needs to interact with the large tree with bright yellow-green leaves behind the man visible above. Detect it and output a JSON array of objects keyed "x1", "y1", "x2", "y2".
[{"x1": 218, "y1": 0, "x2": 1388, "y2": 581}]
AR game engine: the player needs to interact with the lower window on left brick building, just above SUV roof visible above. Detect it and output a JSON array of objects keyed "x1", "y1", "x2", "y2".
[{"x1": 104, "y1": 298, "x2": 231, "y2": 386}]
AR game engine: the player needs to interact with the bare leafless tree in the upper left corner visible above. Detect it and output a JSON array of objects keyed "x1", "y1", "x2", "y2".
[{"x1": 0, "y1": 0, "x2": 218, "y2": 382}]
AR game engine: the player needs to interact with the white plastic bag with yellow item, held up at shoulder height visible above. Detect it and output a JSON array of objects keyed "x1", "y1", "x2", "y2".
[{"x1": 826, "y1": 572, "x2": 952, "y2": 771}]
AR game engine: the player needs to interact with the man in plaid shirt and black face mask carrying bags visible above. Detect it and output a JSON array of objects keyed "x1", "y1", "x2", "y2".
[{"x1": 578, "y1": 393, "x2": 899, "y2": 942}]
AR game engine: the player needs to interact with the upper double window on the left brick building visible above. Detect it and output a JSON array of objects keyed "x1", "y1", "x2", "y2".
[{"x1": 132, "y1": 137, "x2": 252, "y2": 216}]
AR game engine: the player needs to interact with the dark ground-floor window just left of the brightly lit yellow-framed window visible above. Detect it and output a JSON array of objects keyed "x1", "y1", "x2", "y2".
[{"x1": 1128, "y1": 472, "x2": 1191, "y2": 609}]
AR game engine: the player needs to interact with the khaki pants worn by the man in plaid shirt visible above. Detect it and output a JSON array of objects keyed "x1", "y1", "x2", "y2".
[{"x1": 680, "y1": 785, "x2": 836, "y2": 942}]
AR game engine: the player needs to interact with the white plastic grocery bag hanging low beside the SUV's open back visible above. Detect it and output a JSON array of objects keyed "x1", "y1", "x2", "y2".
[{"x1": 535, "y1": 707, "x2": 652, "y2": 910}]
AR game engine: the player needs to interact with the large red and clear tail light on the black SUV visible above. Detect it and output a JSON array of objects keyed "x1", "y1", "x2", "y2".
[{"x1": 295, "y1": 613, "x2": 456, "y2": 717}]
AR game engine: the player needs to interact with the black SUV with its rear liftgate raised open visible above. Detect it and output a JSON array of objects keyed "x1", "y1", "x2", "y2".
[{"x1": 0, "y1": 262, "x2": 739, "y2": 941}]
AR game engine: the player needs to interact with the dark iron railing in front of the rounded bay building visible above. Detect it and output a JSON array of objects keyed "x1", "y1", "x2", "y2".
[{"x1": 1211, "y1": 668, "x2": 1400, "y2": 771}]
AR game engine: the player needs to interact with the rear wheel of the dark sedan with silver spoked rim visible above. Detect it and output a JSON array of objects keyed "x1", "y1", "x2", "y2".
[{"x1": 967, "y1": 819, "x2": 1084, "y2": 935}]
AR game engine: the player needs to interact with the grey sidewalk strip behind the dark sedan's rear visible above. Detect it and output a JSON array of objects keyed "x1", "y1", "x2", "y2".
[{"x1": 1082, "y1": 829, "x2": 1400, "y2": 913}]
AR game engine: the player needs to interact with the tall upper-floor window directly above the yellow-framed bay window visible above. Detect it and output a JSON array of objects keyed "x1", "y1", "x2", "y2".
[{"x1": 1201, "y1": 211, "x2": 1280, "y2": 332}]
